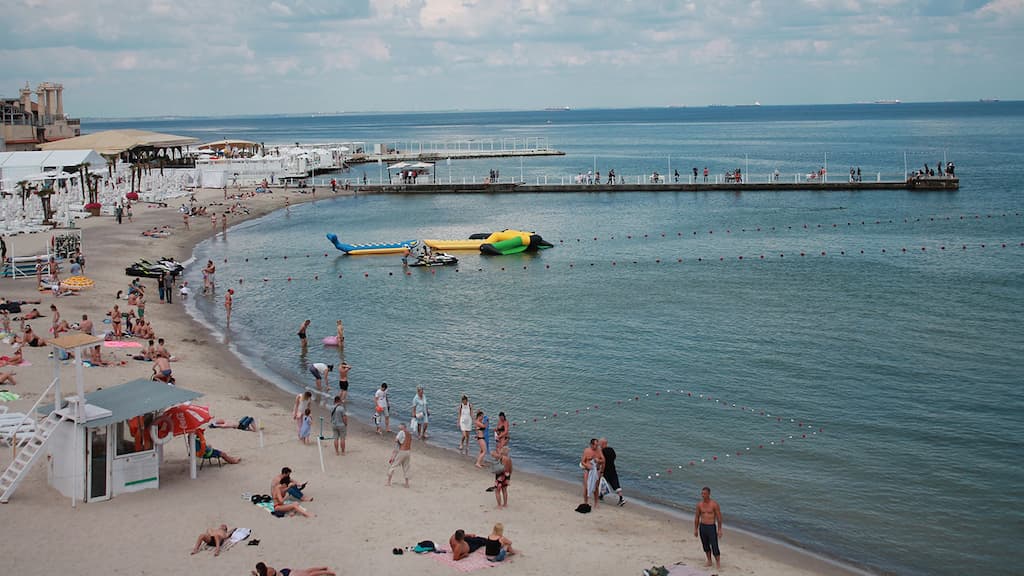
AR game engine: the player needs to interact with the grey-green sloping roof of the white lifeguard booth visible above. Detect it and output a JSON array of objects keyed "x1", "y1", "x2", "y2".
[{"x1": 39, "y1": 378, "x2": 203, "y2": 428}]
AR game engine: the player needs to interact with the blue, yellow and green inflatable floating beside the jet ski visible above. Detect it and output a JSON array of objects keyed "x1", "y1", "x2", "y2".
[{"x1": 327, "y1": 229, "x2": 553, "y2": 255}]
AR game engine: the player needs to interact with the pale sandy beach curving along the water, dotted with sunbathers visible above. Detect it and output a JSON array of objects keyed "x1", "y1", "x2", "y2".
[{"x1": 0, "y1": 190, "x2": 856, "y2": 576}]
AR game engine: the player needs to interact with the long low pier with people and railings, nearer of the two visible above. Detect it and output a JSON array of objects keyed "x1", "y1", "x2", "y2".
[{"x1": 352, "y1": 177, "x2": 959, "y2": 194}]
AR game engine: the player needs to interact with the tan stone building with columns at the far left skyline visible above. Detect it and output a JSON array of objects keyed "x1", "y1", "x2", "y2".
[{"x1": 0, "y1": 82, "x2": 82, "y2": 152}]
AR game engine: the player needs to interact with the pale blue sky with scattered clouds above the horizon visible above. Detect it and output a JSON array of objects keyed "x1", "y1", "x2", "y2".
[{"x1": 0, "y1": 0, "x2": 1024, "y2": 118}]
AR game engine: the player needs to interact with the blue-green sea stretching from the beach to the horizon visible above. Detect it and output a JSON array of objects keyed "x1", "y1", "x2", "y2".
[{"x1": 83, "y1": 101, "x2": 1024, "y2": 575}]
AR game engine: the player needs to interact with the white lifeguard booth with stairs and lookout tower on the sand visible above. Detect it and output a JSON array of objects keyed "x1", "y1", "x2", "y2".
[{"x1": 0, "y1": 334, "x2": 202, "y2": 505}]
